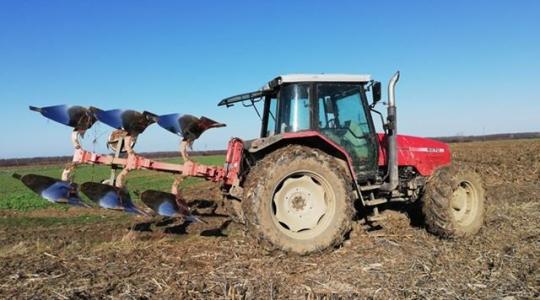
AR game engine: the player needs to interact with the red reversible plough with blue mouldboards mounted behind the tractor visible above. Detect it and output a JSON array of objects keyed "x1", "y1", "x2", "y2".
[{"x1": 14, "y1": 105, "x2": 238, "y2": 220}]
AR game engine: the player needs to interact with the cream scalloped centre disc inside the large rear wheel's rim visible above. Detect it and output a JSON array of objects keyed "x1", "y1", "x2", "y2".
[{"x1": 274, "y1": 175, "x2": 327, "y2": 232}]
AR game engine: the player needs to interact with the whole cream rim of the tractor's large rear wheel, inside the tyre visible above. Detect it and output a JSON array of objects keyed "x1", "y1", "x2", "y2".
[{"x1": 272, "y1": 171, "x2": 335, "y2": 239}]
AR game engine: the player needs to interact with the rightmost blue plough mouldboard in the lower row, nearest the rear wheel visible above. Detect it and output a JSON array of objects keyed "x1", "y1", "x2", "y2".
[{"x1": 141, "y1": 190, "x2": 204, "y2": 222}]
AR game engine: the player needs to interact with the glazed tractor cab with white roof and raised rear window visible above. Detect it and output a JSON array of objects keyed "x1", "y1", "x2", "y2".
[{"x1": 220, "y1": 74, "x2": 380, "y2": 180}]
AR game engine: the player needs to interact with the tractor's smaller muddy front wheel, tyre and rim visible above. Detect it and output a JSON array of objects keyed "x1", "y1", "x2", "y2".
[{"x1": 422, "y1": 166, "x2": 485, "y2": 238}]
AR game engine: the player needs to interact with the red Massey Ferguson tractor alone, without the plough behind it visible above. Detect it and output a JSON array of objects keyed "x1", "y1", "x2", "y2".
[{"x1": 219, "y1": 72, "x2": 484, "y2": 254}]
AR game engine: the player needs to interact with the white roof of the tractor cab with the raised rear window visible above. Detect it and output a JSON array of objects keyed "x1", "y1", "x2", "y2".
[{"x1": 218, "y1": 74, "x2": 371, "y2": 106}]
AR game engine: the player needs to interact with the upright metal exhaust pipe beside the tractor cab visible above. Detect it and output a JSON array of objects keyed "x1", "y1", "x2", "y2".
[{"x1": 381, "y1": 71, "x2": 399, "y2": 191}]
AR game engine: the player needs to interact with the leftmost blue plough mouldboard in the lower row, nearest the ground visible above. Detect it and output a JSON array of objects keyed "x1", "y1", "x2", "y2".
[{"x1": 12, "y1": 174, "x2": 90, "y2": 207}]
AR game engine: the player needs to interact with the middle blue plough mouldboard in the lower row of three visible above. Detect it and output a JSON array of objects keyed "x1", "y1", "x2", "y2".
[{"x1": 81, "y1": 182, "x2": 148, "y2": 216}]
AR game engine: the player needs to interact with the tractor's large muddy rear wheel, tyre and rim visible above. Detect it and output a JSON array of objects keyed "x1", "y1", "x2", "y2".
[{"x1": 242, "y1": 145, "x2": 354, "y2": 254}]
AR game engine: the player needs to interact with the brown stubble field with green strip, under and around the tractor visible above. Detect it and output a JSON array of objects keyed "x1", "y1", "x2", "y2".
[{"x1": 0, "y1": 140, "x2": 540, "y2": 299}]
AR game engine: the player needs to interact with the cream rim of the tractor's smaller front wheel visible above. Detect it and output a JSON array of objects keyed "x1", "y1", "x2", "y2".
[{"x1": 451, "y1": 181, "x2": 479, "y2": 226}]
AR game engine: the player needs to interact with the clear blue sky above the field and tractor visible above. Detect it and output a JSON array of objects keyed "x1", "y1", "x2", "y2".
[{"x1": 0, "y1": 0, "x2": 540, "y2": 158}]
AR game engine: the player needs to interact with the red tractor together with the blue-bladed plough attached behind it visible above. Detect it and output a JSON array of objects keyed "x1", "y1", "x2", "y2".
[{"x1": 20, "y1": 72, "x2": 484, "y2": 254}]
